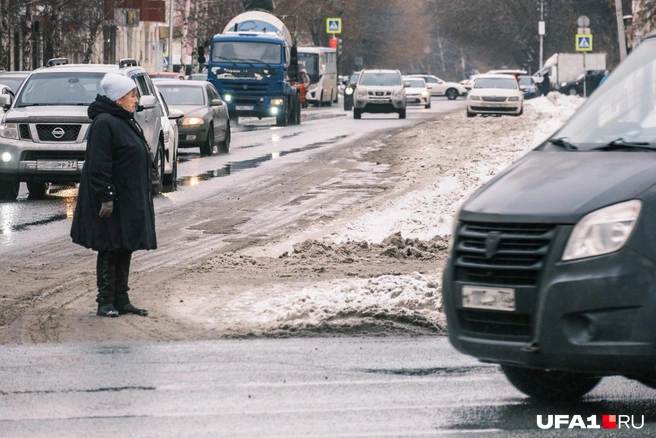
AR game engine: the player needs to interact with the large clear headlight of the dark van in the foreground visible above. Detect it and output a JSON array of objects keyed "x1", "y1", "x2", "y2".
[{"x1": 563, "y1": 199, "x2": 642, "y2": 260}]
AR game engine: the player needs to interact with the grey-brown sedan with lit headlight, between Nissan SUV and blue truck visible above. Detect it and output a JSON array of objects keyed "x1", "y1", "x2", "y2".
[{"x1": 157, "y1": 80, "x2": 231, "y2": 155}]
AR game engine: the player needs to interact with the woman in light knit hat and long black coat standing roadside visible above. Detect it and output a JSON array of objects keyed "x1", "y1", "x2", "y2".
[{"x1": 71, "y1": 73, "x2": 157, "y2": 317}]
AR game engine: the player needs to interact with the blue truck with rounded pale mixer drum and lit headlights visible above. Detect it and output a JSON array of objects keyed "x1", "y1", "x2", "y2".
[{"x1": 207, "y1": 10, "x2": 301, "y2": 126}]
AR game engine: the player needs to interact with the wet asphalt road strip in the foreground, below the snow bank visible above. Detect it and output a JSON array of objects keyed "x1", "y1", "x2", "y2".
[{"x1": 0, "y1": 337, "x2": 656, "y2": 437}]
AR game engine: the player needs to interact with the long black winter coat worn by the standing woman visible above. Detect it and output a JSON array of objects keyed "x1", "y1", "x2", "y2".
[{"x1": 71, "y1": 95, "x2": 157, "y2": 251}]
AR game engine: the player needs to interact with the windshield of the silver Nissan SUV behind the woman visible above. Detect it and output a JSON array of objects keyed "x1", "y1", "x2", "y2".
[{"x1": 16, "y1": 72, "x2": 105, "y2": 107}]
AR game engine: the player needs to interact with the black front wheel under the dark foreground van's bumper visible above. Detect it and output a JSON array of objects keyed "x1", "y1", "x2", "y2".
[{"x1": 501, "y1": 365, "x2": 601, "y2": 402}]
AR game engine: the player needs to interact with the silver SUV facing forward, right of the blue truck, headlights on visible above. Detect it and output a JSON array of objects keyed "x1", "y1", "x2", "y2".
[{"x1": 353, "y1": 70, "x2": 406, "y2": 119}]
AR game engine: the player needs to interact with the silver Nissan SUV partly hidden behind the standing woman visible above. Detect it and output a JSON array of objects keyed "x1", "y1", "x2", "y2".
[{"x1": 0, "y1": 60, "x2": 174, "y2": 199}]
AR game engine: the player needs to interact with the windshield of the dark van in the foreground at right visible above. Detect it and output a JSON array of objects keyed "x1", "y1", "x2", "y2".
[{"x1": 554, "y1": 39, "x2": 656, "y2": 150}]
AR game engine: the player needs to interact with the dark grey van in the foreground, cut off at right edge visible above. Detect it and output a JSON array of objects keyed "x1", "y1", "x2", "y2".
[{"x1": 443, "y1": 33, "x2": 656, "y2": 401}]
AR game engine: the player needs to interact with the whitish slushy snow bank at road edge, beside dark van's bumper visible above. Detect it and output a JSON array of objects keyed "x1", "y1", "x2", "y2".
[{"x1": 225, "y1": 272, "x2": 444, "y2": 334}]
